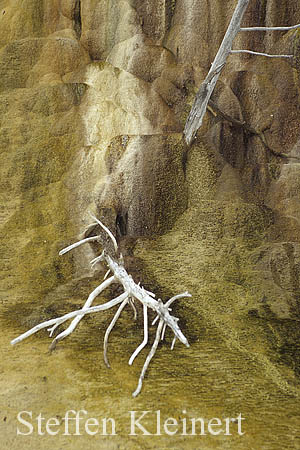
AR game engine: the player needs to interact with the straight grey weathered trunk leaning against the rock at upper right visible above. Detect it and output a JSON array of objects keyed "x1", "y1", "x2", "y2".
[{"x1": 183, "y1": 0, "x2": 250, "y2": 145}]
